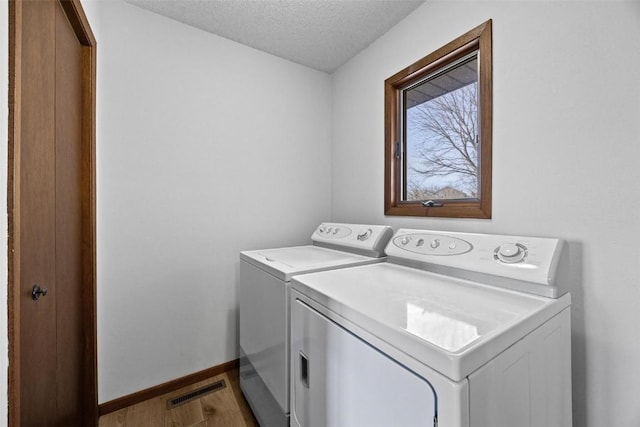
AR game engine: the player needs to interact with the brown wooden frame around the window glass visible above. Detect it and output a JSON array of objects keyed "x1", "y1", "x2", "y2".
[{"x1": 384, "y1": 20, "x2": 493, "y2": 218}]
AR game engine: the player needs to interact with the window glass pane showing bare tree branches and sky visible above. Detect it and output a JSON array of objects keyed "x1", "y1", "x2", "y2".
[{"x1": 403, "y1": 52, "x2": 480, "y2": 201}]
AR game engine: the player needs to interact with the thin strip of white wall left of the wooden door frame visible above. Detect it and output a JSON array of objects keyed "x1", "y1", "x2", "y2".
[{"x1": 0, "y1": 0, "x2": 9, "y2": 425}]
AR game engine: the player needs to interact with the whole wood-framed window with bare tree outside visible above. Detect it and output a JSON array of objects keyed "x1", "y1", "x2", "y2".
[{"x1": 385, "y1": 20, "x2": 492, "y2": 218}]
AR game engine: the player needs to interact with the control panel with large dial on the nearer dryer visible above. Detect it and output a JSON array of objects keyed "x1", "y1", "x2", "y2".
[{"x1": 385, "y1": 229, "x2": 564, "y2": 297}]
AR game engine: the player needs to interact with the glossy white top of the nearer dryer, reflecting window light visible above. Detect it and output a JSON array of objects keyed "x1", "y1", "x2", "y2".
[{"x1": 292, "y1": 263, "x2": 570, "y2": 381}]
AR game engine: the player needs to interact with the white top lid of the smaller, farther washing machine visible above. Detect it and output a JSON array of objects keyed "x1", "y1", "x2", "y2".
[{"x1": 240, "y1": 245, "x2": 385, "y2": 281}]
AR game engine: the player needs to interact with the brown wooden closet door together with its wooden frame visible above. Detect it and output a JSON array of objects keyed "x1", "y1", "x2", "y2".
[{"x1": 8, "y1": 0, "x2": 97, "y2": 426}]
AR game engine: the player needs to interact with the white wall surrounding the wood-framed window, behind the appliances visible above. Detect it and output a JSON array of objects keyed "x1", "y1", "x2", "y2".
[{"x1": 331, "y1": 1, "x2": 640, "y2": 427}]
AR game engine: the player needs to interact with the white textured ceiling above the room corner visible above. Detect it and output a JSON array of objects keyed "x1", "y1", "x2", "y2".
[{"x1": 127, "y1": 0, "x2": 425, "y2": 73}]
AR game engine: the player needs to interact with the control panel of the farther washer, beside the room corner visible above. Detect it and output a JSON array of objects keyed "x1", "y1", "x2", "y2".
[{"x1": 311, "y1": 222, "x2": 393, "y2": 257}]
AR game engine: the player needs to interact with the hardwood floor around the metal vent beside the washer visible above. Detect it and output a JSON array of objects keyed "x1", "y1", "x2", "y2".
[{"x1": 98, "y1": 369, "x2": 258, "y2": 427}]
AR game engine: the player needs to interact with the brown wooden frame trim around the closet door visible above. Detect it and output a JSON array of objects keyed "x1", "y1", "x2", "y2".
[{"x1": 7, "y1": 0, "x2": 98, "y2": 426}]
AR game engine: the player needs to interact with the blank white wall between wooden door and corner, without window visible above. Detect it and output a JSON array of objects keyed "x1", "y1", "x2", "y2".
[{"x1": 97, "y1": 1, "x2": 331, "y2": 403}]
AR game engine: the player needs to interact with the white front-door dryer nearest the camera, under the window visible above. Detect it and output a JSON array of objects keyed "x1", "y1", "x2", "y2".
[{"x1": 290, "y1": 229, "x2": 572, "y2": 427}]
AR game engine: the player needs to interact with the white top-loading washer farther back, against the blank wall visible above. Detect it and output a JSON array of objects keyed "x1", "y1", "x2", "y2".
[{"x1": 238, "y1": 223, "x2": 393, "y2": 427}]
